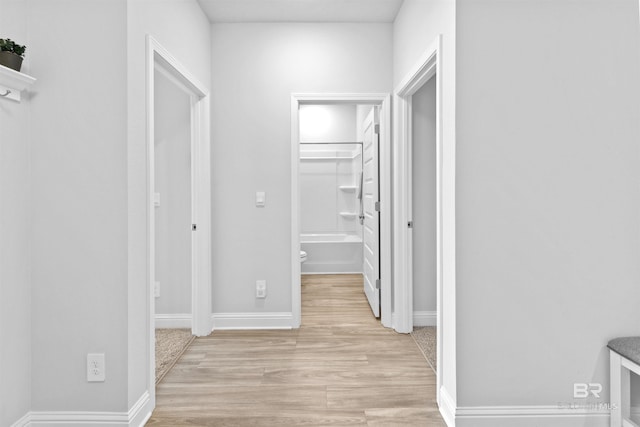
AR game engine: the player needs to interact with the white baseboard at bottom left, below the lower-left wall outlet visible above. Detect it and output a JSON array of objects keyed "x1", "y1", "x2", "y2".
[{"x1": 11, "y1": 391, "x2": 153, "y2": 427}]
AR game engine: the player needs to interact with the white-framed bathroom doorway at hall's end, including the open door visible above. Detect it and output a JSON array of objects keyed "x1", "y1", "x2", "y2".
[{"x1": 291, "y1": 94, "x2": 392, "y2": 328}]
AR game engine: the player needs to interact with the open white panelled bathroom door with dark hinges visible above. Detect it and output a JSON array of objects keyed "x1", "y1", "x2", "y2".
[{"x1": 362, "y1": 107, "x2": 380, "y2": 317}]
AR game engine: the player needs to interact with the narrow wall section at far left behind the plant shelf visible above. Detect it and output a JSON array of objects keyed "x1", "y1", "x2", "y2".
[{"x1": 0, "y1": 0, "x2": 32, "y2": 426}]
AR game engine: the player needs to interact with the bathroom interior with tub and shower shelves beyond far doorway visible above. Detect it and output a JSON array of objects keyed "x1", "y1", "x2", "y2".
[{"x1": 299, "y1": 104, "x2": 374, "y2": 282}]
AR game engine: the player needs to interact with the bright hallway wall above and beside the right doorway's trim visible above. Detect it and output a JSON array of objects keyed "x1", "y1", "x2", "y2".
[{"x1": 393, "y1": 0, "x2": 457, "y2": 401}]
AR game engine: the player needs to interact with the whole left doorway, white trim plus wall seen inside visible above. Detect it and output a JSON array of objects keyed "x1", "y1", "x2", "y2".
[{"x1": 146, "y1": 36, "x2": 212, "y2": 401}]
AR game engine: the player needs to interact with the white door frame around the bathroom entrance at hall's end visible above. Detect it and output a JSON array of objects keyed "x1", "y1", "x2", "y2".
[{"x1": 291, "y1": 93, "x2": 392, "y2": 328}]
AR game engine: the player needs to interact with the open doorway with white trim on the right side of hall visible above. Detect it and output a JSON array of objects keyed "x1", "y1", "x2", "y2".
[{"x1": 394, "y1": 36, "x2": 444, "y2": 405}]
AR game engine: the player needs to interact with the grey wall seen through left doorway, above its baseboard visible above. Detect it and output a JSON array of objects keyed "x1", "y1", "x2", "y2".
[{"x1": 154, "y1": 71, "x2": 193, "y2": 314}]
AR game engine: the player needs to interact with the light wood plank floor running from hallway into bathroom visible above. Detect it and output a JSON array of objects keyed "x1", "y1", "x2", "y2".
[{"x1": 147, "y1": 275, "x2": 445, "y2": 427}]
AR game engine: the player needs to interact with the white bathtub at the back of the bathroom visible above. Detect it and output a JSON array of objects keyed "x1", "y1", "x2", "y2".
[{"x1": 300, "y1": 233, "x2": 363, "y2": 274}]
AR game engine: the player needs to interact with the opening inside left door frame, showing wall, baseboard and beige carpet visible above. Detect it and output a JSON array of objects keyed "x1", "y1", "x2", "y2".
[{"x1": 154, "y1": 69, "x2": 195, "y2": 382}]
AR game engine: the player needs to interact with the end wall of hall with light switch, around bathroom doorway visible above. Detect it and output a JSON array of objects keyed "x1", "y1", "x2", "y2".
[{"x1": 212, "y1": 24, "x2": 392, "y2": 313}]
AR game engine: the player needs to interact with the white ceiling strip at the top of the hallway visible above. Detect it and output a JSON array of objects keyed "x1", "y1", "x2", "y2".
[{"x1": 198, "y1": 0, "x2": 403, "y2": 22}]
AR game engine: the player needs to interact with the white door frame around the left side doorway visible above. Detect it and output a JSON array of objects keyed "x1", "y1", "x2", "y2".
[{"x1": 145, "y1": 35, "x2": 212, "y2": 395}]
